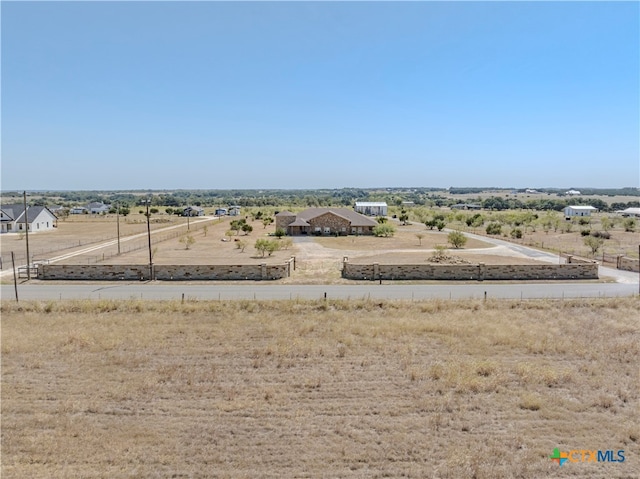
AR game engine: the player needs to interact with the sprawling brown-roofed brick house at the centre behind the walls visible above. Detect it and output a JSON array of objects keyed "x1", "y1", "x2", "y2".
[{"x1": 276, "y1": 208, "x2": 378, "y2": 236}]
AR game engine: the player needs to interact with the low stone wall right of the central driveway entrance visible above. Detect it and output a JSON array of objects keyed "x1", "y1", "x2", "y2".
[{"x1": 342, "y1": 261, "x2": 598, "y2": 281}]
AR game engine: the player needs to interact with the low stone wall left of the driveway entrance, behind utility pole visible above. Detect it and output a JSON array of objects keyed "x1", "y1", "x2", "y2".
[{"x1": 38, "y1": 260, "x2": 293, "y2": 281}]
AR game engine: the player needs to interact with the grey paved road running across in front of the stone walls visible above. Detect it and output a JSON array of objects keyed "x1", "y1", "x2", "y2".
[{"x1": 0, "y1": 281, "x2": 638, "y2": 300}]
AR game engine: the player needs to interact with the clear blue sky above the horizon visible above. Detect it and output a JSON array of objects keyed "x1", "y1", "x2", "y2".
[{"x1": 1, "y1": 1, "x2": 640, "y2": 190}]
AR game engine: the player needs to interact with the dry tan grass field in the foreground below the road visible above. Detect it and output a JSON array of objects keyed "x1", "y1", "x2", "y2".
[{"x1": 1, "y1": 298, "x2": 640, "y2": 479}]
